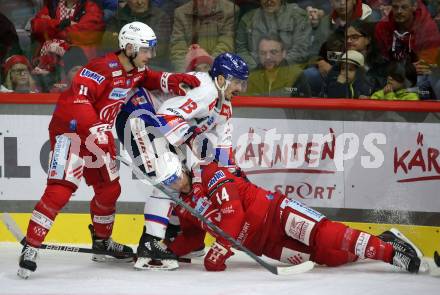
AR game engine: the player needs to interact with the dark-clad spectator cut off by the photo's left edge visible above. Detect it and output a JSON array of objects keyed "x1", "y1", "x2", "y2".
[{"x1": 0, "y1": 12, "x2": 22, "y2": 64}]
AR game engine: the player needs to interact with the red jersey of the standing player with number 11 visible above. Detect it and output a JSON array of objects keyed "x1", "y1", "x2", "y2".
[{"x1": 49, "y1": 53, "x2": 162, "y2": 136}]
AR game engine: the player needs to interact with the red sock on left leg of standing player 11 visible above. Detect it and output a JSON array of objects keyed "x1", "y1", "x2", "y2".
[{"x1": 26, "y1": 184, "x2": 74, "y2": 247}]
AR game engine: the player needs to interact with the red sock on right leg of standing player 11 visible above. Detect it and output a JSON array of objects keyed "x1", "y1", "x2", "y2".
[{"x1": 90, "y1": 181, "x2": 121, "y2": 239}]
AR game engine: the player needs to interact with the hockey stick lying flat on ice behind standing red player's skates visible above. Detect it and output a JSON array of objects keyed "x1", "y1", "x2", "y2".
[{"x1": 1, "y1": 212, "x2": 191, "y2": 263}]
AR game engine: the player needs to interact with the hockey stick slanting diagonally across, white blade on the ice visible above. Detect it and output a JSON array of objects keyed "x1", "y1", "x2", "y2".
[{"x1": 116, "y1": 156, "x2": 315, "y2": 275}]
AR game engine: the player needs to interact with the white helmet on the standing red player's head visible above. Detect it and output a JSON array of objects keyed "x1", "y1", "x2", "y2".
[{"x1": 118, "y1": 22, "x2": 157, "y2": 53}]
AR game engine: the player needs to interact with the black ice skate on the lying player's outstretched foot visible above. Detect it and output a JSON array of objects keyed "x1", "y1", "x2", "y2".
[{"x1": 379, "y1": 228, "x2": 423, "y2": 273}]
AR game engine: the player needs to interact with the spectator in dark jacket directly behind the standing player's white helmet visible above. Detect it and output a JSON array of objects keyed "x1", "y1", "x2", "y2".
[{"x1": 102, "y1": 0, "x2": 171, "y2": 70}]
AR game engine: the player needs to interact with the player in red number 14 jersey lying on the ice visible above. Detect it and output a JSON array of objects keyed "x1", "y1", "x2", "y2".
[{"x1": 153, "y1": 153, "x2": 420, "y2": 273}]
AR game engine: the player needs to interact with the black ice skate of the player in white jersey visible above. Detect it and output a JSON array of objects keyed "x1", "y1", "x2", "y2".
[{"x1": 134, "y1": 227, "x2": 179, "y2": 270}]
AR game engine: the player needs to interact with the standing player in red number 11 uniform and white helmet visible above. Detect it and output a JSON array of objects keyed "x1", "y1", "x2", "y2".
[{"x1": 18, "y1": 22, "x2": 200, "y2": 278}]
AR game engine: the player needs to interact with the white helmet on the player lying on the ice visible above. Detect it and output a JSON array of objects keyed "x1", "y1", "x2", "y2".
[{"x1": 156, "y1": 152, "x2": 184, "y2": 186}]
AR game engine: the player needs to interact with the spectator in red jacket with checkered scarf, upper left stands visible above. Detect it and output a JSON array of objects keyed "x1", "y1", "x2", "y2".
[{"x1": 31, "y1": 0, "x2": 105, "y2": 58}]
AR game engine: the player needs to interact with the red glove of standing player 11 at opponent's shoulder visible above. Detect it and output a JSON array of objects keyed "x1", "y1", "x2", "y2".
[{"x1": 160, "y1": 72, "x2": 200, "y2": 96}]
